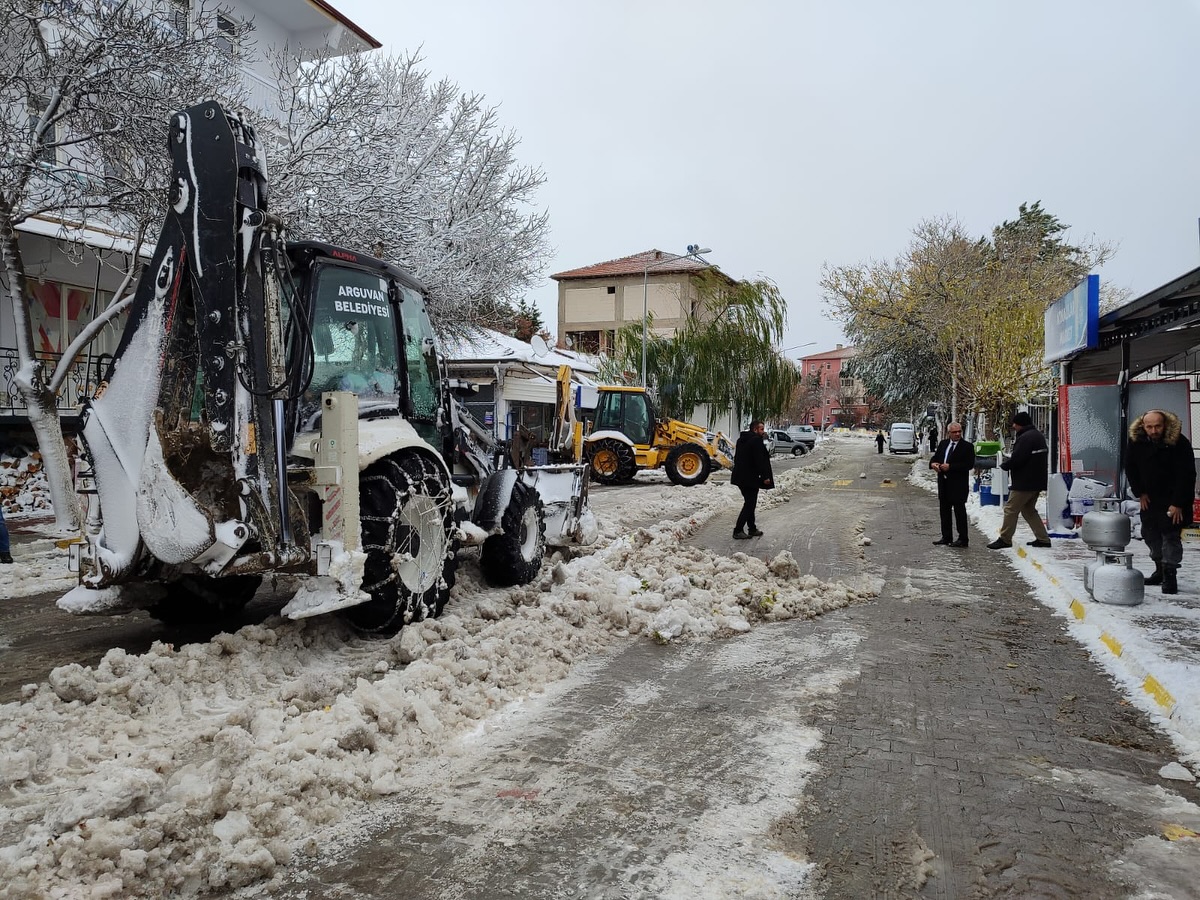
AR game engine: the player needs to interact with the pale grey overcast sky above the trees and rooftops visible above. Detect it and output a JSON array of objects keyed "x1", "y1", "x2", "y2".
[{"x1": 334, "y1": 0, "x2": 1200, "y2": 356}]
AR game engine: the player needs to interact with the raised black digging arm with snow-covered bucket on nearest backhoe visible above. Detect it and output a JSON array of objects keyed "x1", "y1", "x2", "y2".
[{"x1": 80, "y1": 102, "x2": 311, "y2": 588}]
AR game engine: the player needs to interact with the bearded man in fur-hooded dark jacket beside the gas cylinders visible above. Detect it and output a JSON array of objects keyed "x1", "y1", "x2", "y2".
[{"x1": 1126, "y1": 409, "x2": 1196, "y2": 594}]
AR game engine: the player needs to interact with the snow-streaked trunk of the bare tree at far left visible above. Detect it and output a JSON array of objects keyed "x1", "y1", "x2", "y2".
[{"x1": 0, "y1": 207, "x2": 79, "y2": 533}]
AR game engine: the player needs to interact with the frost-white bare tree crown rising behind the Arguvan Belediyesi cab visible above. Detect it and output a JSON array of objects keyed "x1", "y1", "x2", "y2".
[{"x1": 268, "y1": 53, "x2": 548, "y2": 332}]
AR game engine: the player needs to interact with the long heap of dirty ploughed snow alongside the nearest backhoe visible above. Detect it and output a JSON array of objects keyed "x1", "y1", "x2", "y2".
[{"x1": 0, "y1": 441, "x2": 880, "y2": 898}]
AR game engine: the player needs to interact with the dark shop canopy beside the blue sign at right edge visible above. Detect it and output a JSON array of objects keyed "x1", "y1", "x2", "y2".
[{"x1": 1069, "y1": 269, "x2": 1200, "y2": 384}]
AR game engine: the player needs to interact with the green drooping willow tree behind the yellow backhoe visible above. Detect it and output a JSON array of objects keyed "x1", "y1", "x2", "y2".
[{"x1": 612, "y1": 269, "x2": 799, "y2": 421}]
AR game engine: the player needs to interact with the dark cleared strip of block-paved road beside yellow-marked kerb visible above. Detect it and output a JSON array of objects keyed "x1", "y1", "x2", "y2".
[{"x1": 798, "y1": 451, "x2": 1200, "y2": 900}]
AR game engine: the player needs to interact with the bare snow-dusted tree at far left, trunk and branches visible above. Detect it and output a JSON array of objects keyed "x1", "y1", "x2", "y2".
[{"x1": 0, "y1": 0, "x2": 245, "y2": 529}]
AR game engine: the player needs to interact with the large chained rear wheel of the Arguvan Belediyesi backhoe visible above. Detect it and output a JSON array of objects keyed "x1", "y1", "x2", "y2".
[{"x1": 344, "y1": 452, "x2": 457, "y2": 634}]
